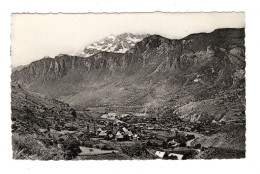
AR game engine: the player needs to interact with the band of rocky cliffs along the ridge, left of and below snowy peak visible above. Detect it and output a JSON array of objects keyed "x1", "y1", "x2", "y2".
[{"x1": 12, "y1": 52, "x2": 122, "y2": 85}]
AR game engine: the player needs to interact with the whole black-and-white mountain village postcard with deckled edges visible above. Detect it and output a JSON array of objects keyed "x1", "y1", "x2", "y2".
[{"x1": 9, "y1": 12, "x2": 247, "y2": 161}]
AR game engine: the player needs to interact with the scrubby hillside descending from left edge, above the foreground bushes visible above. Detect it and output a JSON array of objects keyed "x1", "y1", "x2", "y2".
[{"x1": 11, "y1": 84, "x2": 77, "y2": 134}]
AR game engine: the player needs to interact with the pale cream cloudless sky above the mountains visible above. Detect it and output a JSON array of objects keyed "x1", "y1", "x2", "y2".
[{"x1": 11, "y1": 12, "x2": 245, "y2": 67}]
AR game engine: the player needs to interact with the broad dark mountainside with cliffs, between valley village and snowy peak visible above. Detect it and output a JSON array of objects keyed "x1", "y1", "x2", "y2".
[{"x1": 12, "y1": 28, "x2": 245, "y2": 121}]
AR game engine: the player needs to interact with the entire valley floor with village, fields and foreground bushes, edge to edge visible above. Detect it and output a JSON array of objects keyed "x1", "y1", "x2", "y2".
[{"x1": 13, "y1": 105, "x2": 245, "y2": 160}]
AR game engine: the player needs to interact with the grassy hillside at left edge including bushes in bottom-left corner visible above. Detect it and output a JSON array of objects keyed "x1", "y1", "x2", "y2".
[{"x1": 11, "y1": 85, "x2": 78, "y2": 160}]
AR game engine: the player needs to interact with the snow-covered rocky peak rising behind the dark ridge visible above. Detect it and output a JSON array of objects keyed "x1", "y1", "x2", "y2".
[{"x1": 74, "y1": 33, "x2": 148, "y2": 57}]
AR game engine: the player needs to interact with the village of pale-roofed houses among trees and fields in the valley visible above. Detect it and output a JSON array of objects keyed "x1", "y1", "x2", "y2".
[{"x1": 33, "y1": 108, "x2": 222, "y2": 160}]
